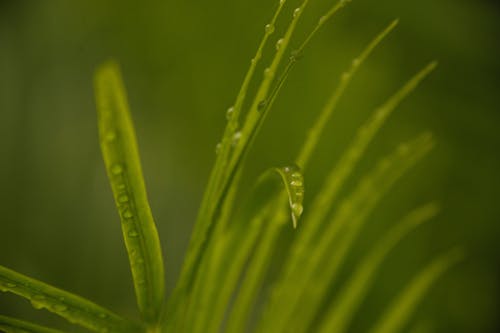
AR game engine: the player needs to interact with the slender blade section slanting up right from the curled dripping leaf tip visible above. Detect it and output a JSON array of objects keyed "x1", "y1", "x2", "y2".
[{"x1": 297, "y1": 20, "x2": 398, "y2": 169}]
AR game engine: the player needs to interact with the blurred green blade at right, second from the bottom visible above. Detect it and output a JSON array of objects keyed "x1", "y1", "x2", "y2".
[{"x1": 315, "y1": 204, "x2": 438, "y2": 333}]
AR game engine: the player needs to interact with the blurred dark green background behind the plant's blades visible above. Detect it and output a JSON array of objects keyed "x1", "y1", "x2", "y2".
[{"x1": 0, "y1": 0, "x2": 500, "y2": 333}]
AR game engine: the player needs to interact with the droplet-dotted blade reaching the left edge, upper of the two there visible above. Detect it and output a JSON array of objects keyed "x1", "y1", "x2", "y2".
[{"x1": 0, "y1": 266, "x2": 140, "y2": 333}]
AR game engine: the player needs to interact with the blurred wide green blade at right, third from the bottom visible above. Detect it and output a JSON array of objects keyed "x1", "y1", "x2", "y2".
[{"x1": 292, "y1": 133, "x2": 433, "y2": 332}]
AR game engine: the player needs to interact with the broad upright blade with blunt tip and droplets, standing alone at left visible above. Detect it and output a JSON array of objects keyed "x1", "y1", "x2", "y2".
[{"x1": 95, "y1": 62, "x2": 165, "y2": 323}]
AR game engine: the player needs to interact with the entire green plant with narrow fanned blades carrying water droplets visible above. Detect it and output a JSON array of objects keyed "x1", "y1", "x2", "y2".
[{"x1": 0, "y1": 0, "x2": 460, "y2": 333}]
